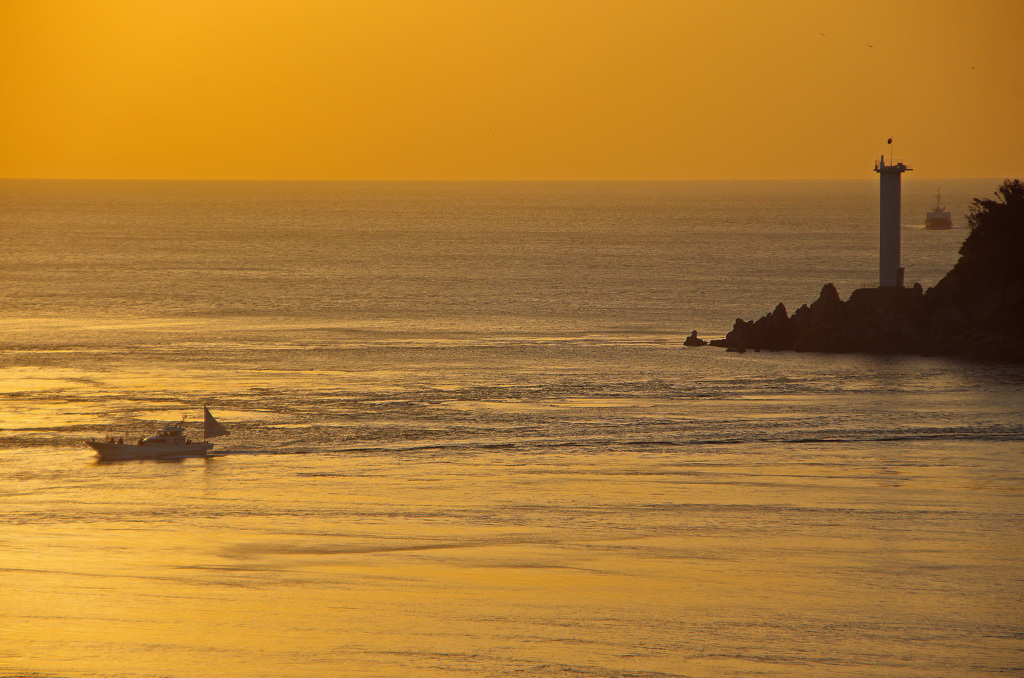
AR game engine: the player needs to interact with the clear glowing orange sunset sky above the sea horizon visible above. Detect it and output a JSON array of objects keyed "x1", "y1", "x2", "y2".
[{"x1": 0, "y1": 0, "x2": 1024, "y2": 179}]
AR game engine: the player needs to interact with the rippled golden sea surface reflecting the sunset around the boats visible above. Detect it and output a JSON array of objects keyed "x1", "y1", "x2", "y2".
[{"x1": 0, "y1": 180, "x2": 1024, "y2": 678}]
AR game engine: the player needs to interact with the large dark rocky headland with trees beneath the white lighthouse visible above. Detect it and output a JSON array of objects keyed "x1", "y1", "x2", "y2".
[{"x1": 711, "y1": 179, "x2": 1024, "y2": 363}]
